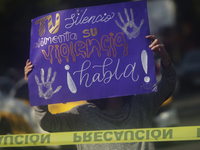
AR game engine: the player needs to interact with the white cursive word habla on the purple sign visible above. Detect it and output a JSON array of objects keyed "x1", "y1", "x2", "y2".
[{"x1": 73, "y1": 58, "x2": 139, "y2": 88}]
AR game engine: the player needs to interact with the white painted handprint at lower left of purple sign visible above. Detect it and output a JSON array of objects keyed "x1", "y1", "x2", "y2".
[{"x1": 35, "y1": 67, "x2": 62, "y2": 99}]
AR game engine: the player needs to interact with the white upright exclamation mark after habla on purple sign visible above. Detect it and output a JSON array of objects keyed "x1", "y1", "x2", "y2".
[{"x1": 141, "y1": 50, "x2": 150, "y2": 83}]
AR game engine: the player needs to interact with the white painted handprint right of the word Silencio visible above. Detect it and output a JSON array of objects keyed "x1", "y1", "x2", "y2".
[{"x1": 115, "y1": 8, "x2": 144, "y2": 39}]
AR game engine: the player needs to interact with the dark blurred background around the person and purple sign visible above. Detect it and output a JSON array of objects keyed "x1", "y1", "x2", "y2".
[{"x1": 0, "y1": 0, "x2": 200, "y2": 150}]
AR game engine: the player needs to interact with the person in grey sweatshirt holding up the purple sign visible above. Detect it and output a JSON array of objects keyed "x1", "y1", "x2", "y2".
[{"x1": 24, "y1": 35, "x2": 176, "y2": 150}]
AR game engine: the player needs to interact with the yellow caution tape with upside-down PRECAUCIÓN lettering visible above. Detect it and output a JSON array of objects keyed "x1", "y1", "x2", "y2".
[{"x1": 0, "y1": 126, "x2": 200, "y2": 147}]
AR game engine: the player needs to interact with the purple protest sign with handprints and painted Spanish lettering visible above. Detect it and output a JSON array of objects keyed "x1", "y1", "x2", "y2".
[{"x1": 28, "y1": 1, "x2": 157, "y2": 106}]
